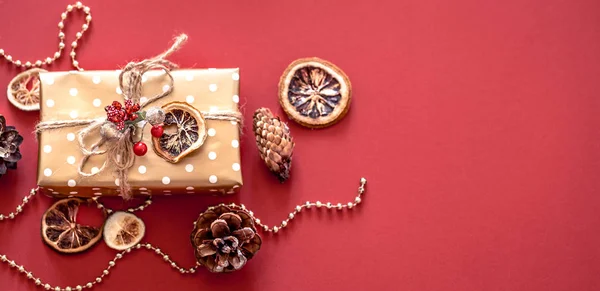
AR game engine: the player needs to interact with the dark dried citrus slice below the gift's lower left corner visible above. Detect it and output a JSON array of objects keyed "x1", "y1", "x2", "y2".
[{"x1": 42, "y1": 198, "x2": 102, "y2": 253}]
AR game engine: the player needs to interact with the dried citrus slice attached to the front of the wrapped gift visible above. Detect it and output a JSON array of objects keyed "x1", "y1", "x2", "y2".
[{"x1": 152, "y1": 102, "x2": 207, "y2": 163}]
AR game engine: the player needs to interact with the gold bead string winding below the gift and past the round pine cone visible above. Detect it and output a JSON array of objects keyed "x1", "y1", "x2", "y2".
[{"x1": 0, "y1": 178, "x2": 367, "y2": 291}]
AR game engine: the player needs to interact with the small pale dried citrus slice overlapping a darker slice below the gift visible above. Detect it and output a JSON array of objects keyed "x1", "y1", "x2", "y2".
[{"x1": 104, "y1": 211, "x2": 146, "y2": 251}]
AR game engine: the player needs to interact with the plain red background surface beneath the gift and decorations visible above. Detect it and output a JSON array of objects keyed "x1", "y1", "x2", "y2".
[{"x1": 0, "y1": 0, "x2": 600, "y2": 291}]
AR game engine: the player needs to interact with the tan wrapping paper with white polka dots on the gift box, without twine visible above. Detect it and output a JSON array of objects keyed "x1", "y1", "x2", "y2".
[{"x1": 37, "y1": 69, "x2": 243, "y2": 197}]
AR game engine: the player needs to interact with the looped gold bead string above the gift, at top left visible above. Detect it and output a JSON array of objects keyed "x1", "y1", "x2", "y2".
[{"x1": 0, "y1": 2, "x2": 92, "y2": 71}]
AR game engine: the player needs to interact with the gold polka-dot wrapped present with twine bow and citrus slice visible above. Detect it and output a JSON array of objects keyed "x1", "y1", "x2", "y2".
[{"x1": 32, "y1": 33, "x2": 242, "y2": 198}]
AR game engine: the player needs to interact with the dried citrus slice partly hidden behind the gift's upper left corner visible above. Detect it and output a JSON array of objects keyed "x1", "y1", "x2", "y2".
[{"x1": 6, "y1": 68, "x2": 46, "y2": 111}]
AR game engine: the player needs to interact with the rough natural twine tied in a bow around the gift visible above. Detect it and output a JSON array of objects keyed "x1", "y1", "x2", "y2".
[{"x1": 35, "y1": 34, "x2": 242, "y2": 200}]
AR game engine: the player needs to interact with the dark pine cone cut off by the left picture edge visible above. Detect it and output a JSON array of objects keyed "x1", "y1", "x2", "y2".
[{"x1": 0, "y1": 115, "x2": 23, "y2": 177}]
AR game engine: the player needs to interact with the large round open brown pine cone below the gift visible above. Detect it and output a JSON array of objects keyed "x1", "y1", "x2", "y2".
[{"x1": 191, "y1": 205, "x2": 262, "y2": 273}]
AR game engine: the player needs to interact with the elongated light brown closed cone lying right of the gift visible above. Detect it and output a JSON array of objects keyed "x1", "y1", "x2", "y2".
[{"x1": 254, "y1": 108, "x2": 295, "y2": 183}]
